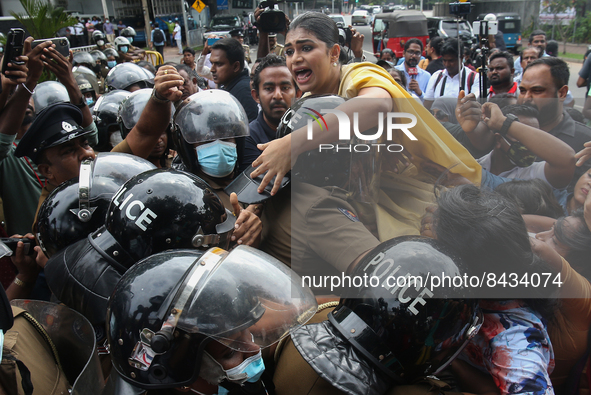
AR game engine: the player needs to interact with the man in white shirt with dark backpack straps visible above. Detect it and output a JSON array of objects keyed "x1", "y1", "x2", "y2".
[{"x1": 424, "y1": 38, "x2": 480, "y2": 109}]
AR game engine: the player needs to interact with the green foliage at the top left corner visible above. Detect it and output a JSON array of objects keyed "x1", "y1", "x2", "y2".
[{"x1": 10, "y1": 0, "x2": 77, "y2": 39}]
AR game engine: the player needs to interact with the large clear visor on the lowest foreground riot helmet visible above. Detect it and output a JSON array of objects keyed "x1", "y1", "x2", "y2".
[{"x1": 169, "y1": 246, "x2": 317, "y2": 352}]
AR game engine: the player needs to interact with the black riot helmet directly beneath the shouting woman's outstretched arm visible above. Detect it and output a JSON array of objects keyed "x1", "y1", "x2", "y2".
[{"x1": 277, "y1": 95, "x2": 351, "y2": 187}]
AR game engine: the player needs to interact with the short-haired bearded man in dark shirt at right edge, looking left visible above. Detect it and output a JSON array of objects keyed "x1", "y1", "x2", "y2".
[{"x1": 518, "y1": 56, "x2": 591, "y2": 189}]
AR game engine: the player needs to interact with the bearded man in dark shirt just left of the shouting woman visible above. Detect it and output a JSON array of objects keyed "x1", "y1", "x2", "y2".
[{"x1": 240, "y1": 54, "x2": 296, "y2": 170}]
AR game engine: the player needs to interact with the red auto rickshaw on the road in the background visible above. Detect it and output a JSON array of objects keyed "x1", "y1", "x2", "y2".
[{"x1": 372, "y1": 10, "x2": 429, "y2": 58}]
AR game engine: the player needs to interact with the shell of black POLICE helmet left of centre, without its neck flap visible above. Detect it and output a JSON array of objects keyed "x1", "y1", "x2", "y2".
[{"x1": 104, "y1": 170, "x2": 236, "y2": 267}]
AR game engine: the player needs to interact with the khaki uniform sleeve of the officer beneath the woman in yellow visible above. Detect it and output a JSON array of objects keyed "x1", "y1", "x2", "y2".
[{"x1": 305, "y1": 188, "x2": 380, "y2": 272}]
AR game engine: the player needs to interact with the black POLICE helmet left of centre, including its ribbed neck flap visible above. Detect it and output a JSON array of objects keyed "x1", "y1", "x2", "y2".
[{"x1": 45, "y1": 169, "x2": 235, "y2": 335}]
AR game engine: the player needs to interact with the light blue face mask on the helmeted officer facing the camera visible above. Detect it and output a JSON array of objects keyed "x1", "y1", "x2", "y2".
[{"x1": 195, "y1": 140, "x2": 238, "y2": 178}]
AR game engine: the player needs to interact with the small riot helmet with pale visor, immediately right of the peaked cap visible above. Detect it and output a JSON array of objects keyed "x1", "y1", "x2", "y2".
[{"x1": 92, "y1": 90, "x2": 129, "y2": 151}]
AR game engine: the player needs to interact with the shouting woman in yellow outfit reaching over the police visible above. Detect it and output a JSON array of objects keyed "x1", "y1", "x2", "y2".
[{"x1": 251, "y1": 12, "x2": 481, "y2": 240}]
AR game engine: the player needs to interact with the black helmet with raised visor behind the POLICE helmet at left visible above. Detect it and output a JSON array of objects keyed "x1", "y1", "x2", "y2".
[{"x1": 36, "y1": 152, "x2": 155, "y2": 258}]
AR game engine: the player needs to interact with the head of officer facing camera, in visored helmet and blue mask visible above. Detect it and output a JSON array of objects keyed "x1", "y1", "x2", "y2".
[{"x1": 173, "y1": 89, "x2": 249, "y2": 178}]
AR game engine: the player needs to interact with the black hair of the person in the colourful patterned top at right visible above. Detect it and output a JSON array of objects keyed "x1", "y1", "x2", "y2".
[{"x1": 434, "y1": 184, "x2": 555, "y2": 310}]
